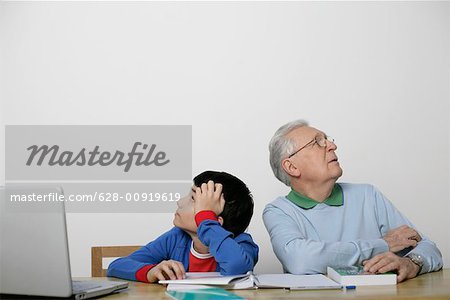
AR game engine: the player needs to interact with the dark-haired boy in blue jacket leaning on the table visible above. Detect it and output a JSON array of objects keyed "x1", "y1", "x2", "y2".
[{"x1": 107, "y1": 171, "x2": 258, "y2": 282}]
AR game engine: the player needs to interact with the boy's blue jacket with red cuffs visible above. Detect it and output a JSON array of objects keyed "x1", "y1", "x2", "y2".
[{"x1": 107, "y1": 220, "x2": 259, "y2": 280}]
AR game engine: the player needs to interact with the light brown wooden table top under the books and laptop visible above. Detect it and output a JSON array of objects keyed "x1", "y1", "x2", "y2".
[{"x1": 79, "y1": 269, "x2": 450, "y2": 300}]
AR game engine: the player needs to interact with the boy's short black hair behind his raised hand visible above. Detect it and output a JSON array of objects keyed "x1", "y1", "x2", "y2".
[{"x1": 194, "y1": 171, "x2": 253, "y2": 236}]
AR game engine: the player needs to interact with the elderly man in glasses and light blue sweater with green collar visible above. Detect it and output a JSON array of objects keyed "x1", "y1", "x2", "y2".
[{"x1": 263, "y1": 120, "x2": 442, "y2": 282}]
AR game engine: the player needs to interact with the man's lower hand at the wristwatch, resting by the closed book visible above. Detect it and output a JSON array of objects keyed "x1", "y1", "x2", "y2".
[{"x1": 363, "y1": 252, "x2": 420, "y2": 282}]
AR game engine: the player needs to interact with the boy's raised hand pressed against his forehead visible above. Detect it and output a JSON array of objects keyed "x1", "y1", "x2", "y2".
[{"x1": 192, "y1": 180, "x2": 225, "y2": 215}]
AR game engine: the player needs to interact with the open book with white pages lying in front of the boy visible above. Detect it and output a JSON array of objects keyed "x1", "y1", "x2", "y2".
[{"x1": 159, "y1": 272, "x2": 342, "y2": 291}]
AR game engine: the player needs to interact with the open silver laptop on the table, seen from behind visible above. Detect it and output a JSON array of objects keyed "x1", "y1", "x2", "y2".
[{"x1": 0, "y1": 185, "x2": 128, "y2": 299}]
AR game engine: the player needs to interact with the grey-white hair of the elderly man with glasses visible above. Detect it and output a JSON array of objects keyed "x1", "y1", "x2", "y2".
[{"x1": 269, "y1": 120, "x2": 309, "y2": 186}]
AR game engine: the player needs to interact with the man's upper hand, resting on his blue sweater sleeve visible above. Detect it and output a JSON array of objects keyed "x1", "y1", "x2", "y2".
[{"x1": 383, "y1": 225, "x2": 422, "y2": 253}]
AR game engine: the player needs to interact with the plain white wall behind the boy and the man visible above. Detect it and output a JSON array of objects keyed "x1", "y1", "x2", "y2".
[{"x1": 0, "y1": 2, "x2": 450, "y2": 276}]
